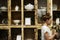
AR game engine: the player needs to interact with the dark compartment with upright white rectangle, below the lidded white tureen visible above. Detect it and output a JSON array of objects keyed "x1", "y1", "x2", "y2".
[{"x1": 24, "y1": 11, "x2": 35, "y2": 25}]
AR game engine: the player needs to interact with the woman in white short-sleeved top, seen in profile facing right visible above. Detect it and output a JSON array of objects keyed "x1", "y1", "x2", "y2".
[{"x1": 41, "y1": 15, "x2": 57, "y2": 40}]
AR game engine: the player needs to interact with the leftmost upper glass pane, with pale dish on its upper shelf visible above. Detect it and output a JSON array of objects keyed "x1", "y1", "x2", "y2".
[{"x1": 0, "y1": 0, "x2": 8, "y2": 24}]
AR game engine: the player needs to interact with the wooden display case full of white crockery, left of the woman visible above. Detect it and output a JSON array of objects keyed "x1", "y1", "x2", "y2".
[{"x1": 0, "y1": 0, "x2": 52, "y2": 40}]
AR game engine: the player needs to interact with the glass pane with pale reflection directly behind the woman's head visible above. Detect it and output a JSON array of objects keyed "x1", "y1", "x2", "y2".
[{"x1": 38, "y1": 0, "x2": 47, "y2": 23}]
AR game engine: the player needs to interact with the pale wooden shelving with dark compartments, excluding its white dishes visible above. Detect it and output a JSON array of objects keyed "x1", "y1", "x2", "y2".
[{"x1": 0, "y1": 0, "x2": 50, "y2": 40}]
